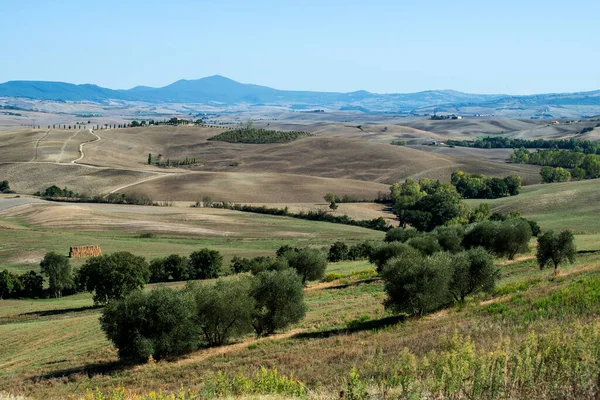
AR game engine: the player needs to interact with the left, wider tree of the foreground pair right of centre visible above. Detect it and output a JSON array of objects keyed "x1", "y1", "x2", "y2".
[{"x1": 381, "y1": 253, "x2": 452, "y2": 315}]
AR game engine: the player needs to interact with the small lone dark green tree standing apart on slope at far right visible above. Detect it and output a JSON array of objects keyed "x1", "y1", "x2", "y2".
[{"x1": 536, "y1": 230, "x2": 577, "y2": 272}]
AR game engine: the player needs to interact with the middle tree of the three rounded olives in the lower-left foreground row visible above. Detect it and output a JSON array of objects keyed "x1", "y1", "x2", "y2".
[{"x1": 186, "y1": 276, "x2": 255, "y2": 346}]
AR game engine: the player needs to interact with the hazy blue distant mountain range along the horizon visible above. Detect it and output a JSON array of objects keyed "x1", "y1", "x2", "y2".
[{"x1": 0, "y1": 75, "x2": 600, "y2": 117}]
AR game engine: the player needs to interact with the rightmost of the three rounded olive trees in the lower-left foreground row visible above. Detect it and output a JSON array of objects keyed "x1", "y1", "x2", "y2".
[{"x1": 251, "y1": 269, "x2": 306, "y2": 337}]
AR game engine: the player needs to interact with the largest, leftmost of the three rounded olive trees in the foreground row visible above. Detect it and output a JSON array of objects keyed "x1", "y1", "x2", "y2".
[{"x1": 100, "y1": 288, "x2": 199, "y2": 362}]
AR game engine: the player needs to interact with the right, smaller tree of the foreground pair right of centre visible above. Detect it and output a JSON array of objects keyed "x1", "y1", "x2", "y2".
[{"x1": 449, "y1": 247, "x2": 500, "y2": 302}]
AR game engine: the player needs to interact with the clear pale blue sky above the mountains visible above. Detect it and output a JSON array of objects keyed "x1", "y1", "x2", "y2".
[{"x1": 0, "y1": 0, "x2": 600, "y2": 94}]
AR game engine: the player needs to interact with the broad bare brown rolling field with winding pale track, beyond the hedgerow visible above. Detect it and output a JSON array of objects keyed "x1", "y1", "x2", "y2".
[{"x1": 0, "y1": 123, "x2": 539, "y2": 203}]
